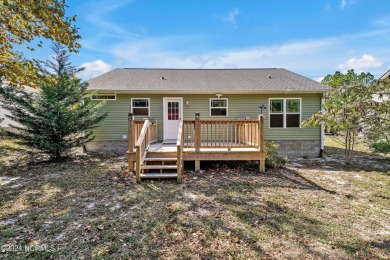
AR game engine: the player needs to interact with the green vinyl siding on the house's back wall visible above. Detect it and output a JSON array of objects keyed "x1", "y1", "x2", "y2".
[{"x1": 94, "y1": 94, "x2": 322, "y2": 141}]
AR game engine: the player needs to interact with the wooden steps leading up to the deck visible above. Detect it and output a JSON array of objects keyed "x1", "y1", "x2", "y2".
[{"x1": 140, "y1": 152, "x2": 178, "y2": 179}]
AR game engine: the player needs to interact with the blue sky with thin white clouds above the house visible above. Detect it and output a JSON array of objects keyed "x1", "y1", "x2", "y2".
[{"x1": 23, "y1": 0, "x2": 390, "y2": 80}]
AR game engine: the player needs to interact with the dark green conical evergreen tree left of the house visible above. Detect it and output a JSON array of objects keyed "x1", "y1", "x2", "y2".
[{"x1": 0, "y1": 44, "x2": 107, "y2": 160}]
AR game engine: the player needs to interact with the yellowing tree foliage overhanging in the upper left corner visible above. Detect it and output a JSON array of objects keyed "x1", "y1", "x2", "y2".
[{"x1": 0, "y1": 0, "x2": 81, "y2": 86}]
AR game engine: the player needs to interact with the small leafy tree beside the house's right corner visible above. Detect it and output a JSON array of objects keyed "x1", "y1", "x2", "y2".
[{"x1": 303, "y1": 70, "x2": 374, "y2": 164}]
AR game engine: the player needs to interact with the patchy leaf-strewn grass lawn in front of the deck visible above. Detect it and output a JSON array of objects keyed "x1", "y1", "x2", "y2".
[{"x1": 0, "y1": 140, "x2": 390, "y2": 259}]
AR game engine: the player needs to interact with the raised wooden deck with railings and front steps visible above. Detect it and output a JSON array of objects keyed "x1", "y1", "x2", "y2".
[{"x1": 128, "y1": 114, "x2": 265, "y2": 182}]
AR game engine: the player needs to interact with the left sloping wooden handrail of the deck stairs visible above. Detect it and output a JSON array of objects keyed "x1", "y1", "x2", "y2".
[{"x1": 135, "y1": 119, "x2": 150, "y2": 182}]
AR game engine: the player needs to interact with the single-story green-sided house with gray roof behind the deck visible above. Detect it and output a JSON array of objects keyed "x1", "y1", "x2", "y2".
[{"x1": 87, "y1": 68, "x2": 331, "y2": 157}]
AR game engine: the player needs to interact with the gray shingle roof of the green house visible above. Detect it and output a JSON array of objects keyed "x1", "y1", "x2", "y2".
[{"x1": 88, "y1": 68, "x2": 330, "y2": 93}]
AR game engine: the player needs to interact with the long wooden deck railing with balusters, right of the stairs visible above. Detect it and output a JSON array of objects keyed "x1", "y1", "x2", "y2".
[{"x1": 183, "y1": 115, "x2": 264, "y2": 152}]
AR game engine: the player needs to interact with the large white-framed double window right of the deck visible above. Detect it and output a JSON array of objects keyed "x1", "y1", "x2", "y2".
[{"x1": 269, "y1": 98, "x2": 301, "y2": 128}]
